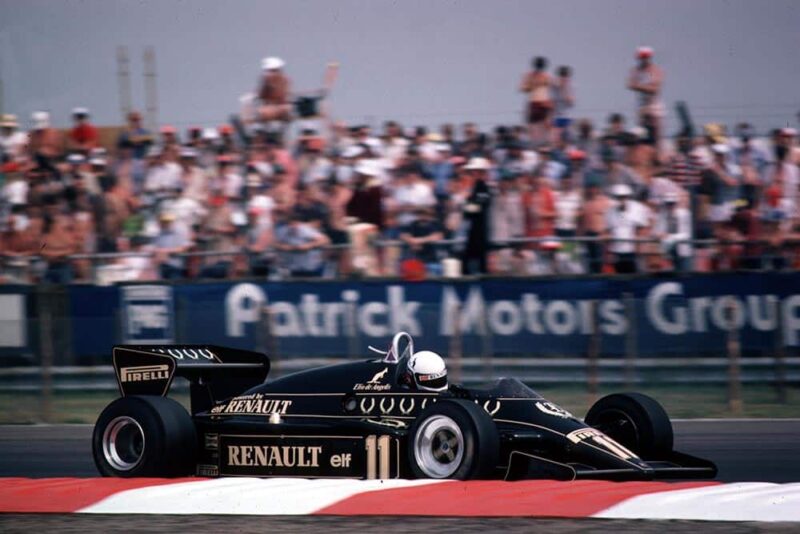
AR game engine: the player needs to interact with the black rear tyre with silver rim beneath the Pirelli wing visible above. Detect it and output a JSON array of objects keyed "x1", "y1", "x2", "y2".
[{"x1": 92, "y1": 396, "x2": 197, "y2": 478}]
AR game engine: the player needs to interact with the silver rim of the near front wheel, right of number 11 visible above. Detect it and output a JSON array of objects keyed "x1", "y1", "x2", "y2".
[{"x1": 414, "y1": 415, "x2": 464, "y2": 478}]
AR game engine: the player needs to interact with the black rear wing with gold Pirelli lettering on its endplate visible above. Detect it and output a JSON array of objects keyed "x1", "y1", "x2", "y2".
[{"x1": 111, "y1": 345, "x2": 269, "y2": 414}]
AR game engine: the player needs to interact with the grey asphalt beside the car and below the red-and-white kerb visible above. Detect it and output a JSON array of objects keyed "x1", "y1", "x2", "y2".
[{"x1": 0, "y1": 419, "x2": 800, "y2": 534}]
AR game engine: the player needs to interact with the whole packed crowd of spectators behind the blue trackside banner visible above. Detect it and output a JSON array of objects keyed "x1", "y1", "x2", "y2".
[{"x1": 0, "y1": 47, "x2": 800, "y2": 283}]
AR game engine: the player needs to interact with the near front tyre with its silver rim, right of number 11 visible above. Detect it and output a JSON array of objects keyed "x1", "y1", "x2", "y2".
[{"x1": 408, "y1": 399, "x2": 500, "y2": 480}]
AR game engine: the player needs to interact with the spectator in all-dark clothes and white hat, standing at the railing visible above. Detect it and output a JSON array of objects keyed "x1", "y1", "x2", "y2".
[{"x1": 462, "y1": 158, "x2": 492, "y2": 274}]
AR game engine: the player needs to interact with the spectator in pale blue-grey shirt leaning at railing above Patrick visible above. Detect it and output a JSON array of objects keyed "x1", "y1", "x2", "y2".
[{"x1": 275, "y1": 213, "x2": 330, "y2": 278}]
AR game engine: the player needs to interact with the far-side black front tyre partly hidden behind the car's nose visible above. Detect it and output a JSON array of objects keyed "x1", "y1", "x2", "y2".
[{"x1": 585, "y1": 393, "x2": 673, "y2": 459}]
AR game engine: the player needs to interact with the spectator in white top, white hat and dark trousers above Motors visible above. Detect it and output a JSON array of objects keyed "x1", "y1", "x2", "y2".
[{"x1": 606, "y1": 184, "x2": 648, "y2": 274}]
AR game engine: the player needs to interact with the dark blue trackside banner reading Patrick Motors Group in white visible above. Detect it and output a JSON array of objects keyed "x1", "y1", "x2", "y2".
[{"x1": 69, "y1": 273, "x2": 800, "y2": 358}]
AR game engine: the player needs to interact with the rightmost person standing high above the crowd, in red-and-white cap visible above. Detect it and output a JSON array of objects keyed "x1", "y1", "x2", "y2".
[{"x1": 628, "y1": 46, "x2": 664, "y2": 145}]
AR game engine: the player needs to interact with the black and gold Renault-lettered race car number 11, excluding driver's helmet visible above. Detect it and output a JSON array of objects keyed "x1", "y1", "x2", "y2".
[{"x1": 93, "y1": 332, "x2": 716, "y2": 480}]
